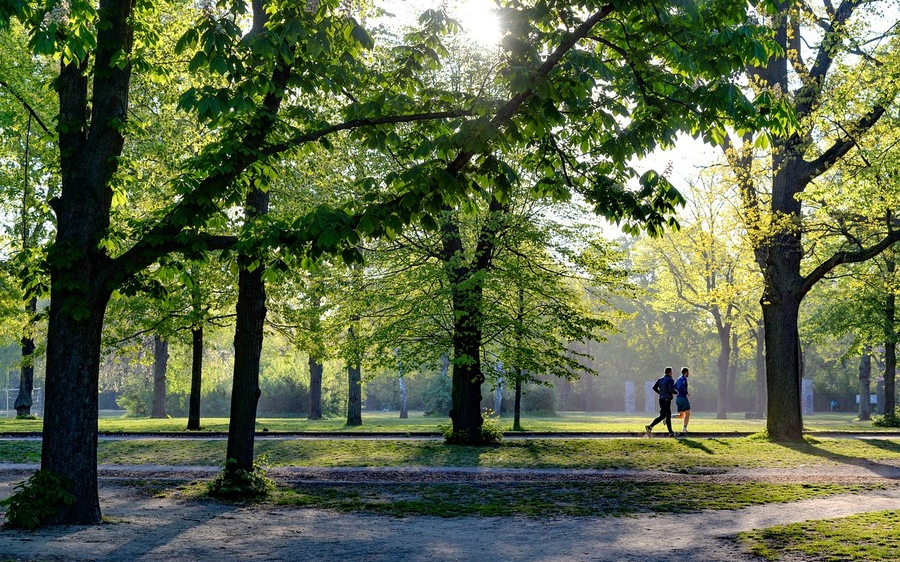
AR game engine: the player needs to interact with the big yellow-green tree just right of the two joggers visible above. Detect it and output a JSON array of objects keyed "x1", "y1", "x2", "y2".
[{"x1": 722, "y1": 0, "x2": 900, "y2": 440}]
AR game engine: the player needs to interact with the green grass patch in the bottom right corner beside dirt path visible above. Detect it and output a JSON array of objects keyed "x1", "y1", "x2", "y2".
[{"x1": 739, "y1": 511, "x2": 900, "y2": 562}]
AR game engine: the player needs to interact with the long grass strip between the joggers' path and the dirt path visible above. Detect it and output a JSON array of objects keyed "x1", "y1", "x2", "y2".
[{"x1": 0, "y1": 437, "x2": 900, "y2": 472}]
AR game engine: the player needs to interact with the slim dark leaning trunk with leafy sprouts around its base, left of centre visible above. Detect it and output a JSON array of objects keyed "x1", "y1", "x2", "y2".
[{"x1": 226, "y1": 189, "x2": 269, "y2": 477}]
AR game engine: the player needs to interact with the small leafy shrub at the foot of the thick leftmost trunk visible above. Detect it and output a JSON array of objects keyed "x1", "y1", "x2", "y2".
[{"x1": 0, "y1": 470, "x2": 75, "y2": 529}]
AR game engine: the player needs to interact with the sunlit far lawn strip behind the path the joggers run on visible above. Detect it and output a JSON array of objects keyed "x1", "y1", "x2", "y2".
[{"x1": 0, "y1": 412, "x2": 897, "y2": 434}]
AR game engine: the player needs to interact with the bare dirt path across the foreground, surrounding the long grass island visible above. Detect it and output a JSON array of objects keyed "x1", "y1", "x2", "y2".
[{"x1": 0, "y1": 465, "x2": 900, "y2": 562}]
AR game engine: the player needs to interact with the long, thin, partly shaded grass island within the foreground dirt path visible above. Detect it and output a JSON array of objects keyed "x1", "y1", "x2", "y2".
[{"x1": 274, "y1": 482, "x2": 873, "y2": 517}]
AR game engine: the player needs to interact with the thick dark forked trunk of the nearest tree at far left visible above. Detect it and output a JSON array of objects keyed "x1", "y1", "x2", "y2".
[{"x1": 41, "y1": 0, "x2": 133, "y2": 524}]
